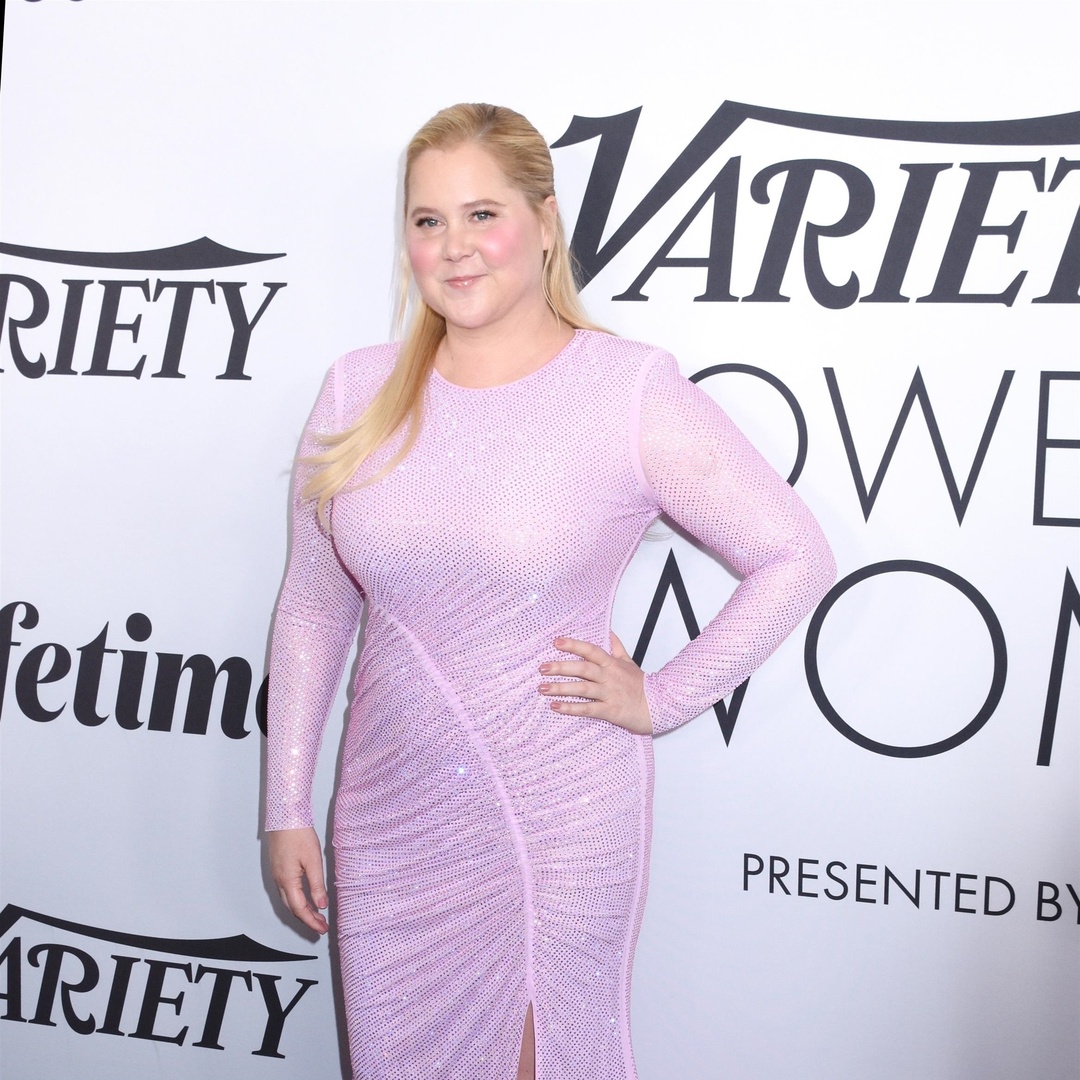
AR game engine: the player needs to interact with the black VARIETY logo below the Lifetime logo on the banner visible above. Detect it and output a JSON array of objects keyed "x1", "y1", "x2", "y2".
[{"x1": 0, "y1": 904, "x2": 319, "y2": 1057}]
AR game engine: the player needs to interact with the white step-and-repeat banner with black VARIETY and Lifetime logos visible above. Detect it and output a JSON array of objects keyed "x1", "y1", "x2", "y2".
[{"x1": 0, "y1": 0, "x2": 1080, "y2": 1080}]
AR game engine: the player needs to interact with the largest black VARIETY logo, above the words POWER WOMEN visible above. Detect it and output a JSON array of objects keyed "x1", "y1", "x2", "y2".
[{"x1": 552, "y1": 102, "x2": 1080, "y2": 308}]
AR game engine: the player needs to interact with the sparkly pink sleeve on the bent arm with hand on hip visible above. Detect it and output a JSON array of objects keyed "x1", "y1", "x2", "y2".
[{"x1": 637, "y1": 353, "x2": 836, "y2": 734}]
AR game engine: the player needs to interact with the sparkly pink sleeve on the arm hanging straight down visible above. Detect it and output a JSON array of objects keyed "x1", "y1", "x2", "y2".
[{"x1": 266, "y1": 367, "x2": 363, "y2": 829}]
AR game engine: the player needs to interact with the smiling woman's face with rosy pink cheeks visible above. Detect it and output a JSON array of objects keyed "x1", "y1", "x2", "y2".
[{"x1": 405, "y1": 143, "x2": 555, "y2": 329}]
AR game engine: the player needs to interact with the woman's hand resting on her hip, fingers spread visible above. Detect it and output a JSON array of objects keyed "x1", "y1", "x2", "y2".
[{"x1": 540, "y1": 634, "x2": 652, "y2": 735}]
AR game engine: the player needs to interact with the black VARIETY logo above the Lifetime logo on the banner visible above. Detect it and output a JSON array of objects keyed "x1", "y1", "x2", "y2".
[{"x1": 0, "y1": 237, "x2": 286, "y2": 381}]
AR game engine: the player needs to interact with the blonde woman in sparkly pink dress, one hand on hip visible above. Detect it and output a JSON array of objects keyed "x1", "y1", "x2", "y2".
[{"x1": 267, "y1": 105, "x2": 833, "y2": 1080}]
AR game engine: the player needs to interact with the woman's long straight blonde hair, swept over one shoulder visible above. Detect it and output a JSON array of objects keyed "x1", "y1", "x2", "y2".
[{"x1": 303, "y1": 104, "x2": 599, "y2": 524}]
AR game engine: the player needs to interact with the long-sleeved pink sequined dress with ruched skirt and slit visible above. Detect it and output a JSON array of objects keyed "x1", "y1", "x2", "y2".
[{"x1": 267, "y1": 330, "x2": 833, "y2": 1080}]
